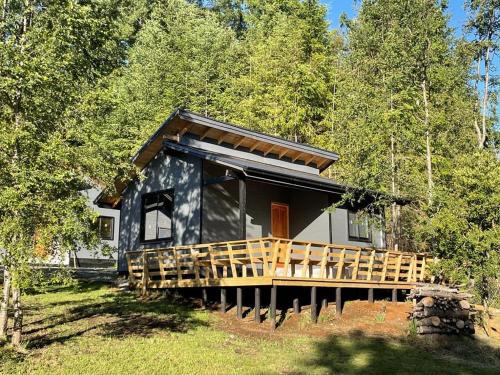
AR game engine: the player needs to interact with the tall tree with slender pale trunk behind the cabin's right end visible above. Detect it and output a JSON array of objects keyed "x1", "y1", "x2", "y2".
[{"x1": 324, "y1": 0, "x2": 472, "y2": 248}]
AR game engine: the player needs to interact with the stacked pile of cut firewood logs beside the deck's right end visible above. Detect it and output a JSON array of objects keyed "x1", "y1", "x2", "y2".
[{"x1": 409, "y1": 284, "x2": 476, "y2": 335}]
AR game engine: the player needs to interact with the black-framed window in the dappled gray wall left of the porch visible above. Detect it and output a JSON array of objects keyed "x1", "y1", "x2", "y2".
[{"x1": 141, "y1": 190, "x2": 174, "y2": 242}]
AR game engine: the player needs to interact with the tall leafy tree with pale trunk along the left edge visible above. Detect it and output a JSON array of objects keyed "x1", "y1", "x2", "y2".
[{"x1": 0, "y1": 0, "x2": 132, "y2": 346}]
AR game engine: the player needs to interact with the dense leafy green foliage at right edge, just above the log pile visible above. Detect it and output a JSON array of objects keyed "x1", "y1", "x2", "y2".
[{"x1": 422, "y1": 151, "x2": 500, "y2": 304}]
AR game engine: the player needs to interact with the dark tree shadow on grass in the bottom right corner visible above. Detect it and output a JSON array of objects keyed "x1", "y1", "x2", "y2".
[{"x1": 303, "y1": 330, "x2": 500, "y2": 374}]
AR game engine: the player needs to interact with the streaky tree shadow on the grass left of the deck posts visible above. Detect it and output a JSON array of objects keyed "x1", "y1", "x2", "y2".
[{"x1": 24, "y1": 284, "x2": 207, "y2": 349}]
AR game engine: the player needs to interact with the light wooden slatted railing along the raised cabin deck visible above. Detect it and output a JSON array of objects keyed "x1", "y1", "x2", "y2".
[{"x1": 126, "y1": 237, "x2": 432, "y2": 288}]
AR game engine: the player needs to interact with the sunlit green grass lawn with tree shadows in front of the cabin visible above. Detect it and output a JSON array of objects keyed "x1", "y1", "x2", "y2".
[{"x1": 0, "y1": 283, "x2": 500, "y2": 375}]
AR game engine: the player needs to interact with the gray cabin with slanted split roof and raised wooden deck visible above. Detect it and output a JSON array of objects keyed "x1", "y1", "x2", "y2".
[{"x1": 96, "y1": 109, "x2": 430, "y2": 326}]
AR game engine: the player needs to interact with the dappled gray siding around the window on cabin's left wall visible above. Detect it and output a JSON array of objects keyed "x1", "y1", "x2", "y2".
[{"x1": 118, "y1": 153, "x2": 201, "y2": 271}]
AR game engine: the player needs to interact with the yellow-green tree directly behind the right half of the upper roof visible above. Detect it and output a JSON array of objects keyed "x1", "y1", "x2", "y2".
[{"x1": 220, "y1": 0, "x2": 334, "y2": 142}]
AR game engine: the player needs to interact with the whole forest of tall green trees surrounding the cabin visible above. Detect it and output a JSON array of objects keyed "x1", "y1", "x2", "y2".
[{"x1": 0, "y1": 0, "x2": 500, "y2": 344}]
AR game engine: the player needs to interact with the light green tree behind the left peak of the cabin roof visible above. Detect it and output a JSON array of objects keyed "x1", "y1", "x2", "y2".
[{"x1": 95, "y1": 0, "x2": 239, "y2": 154}]
